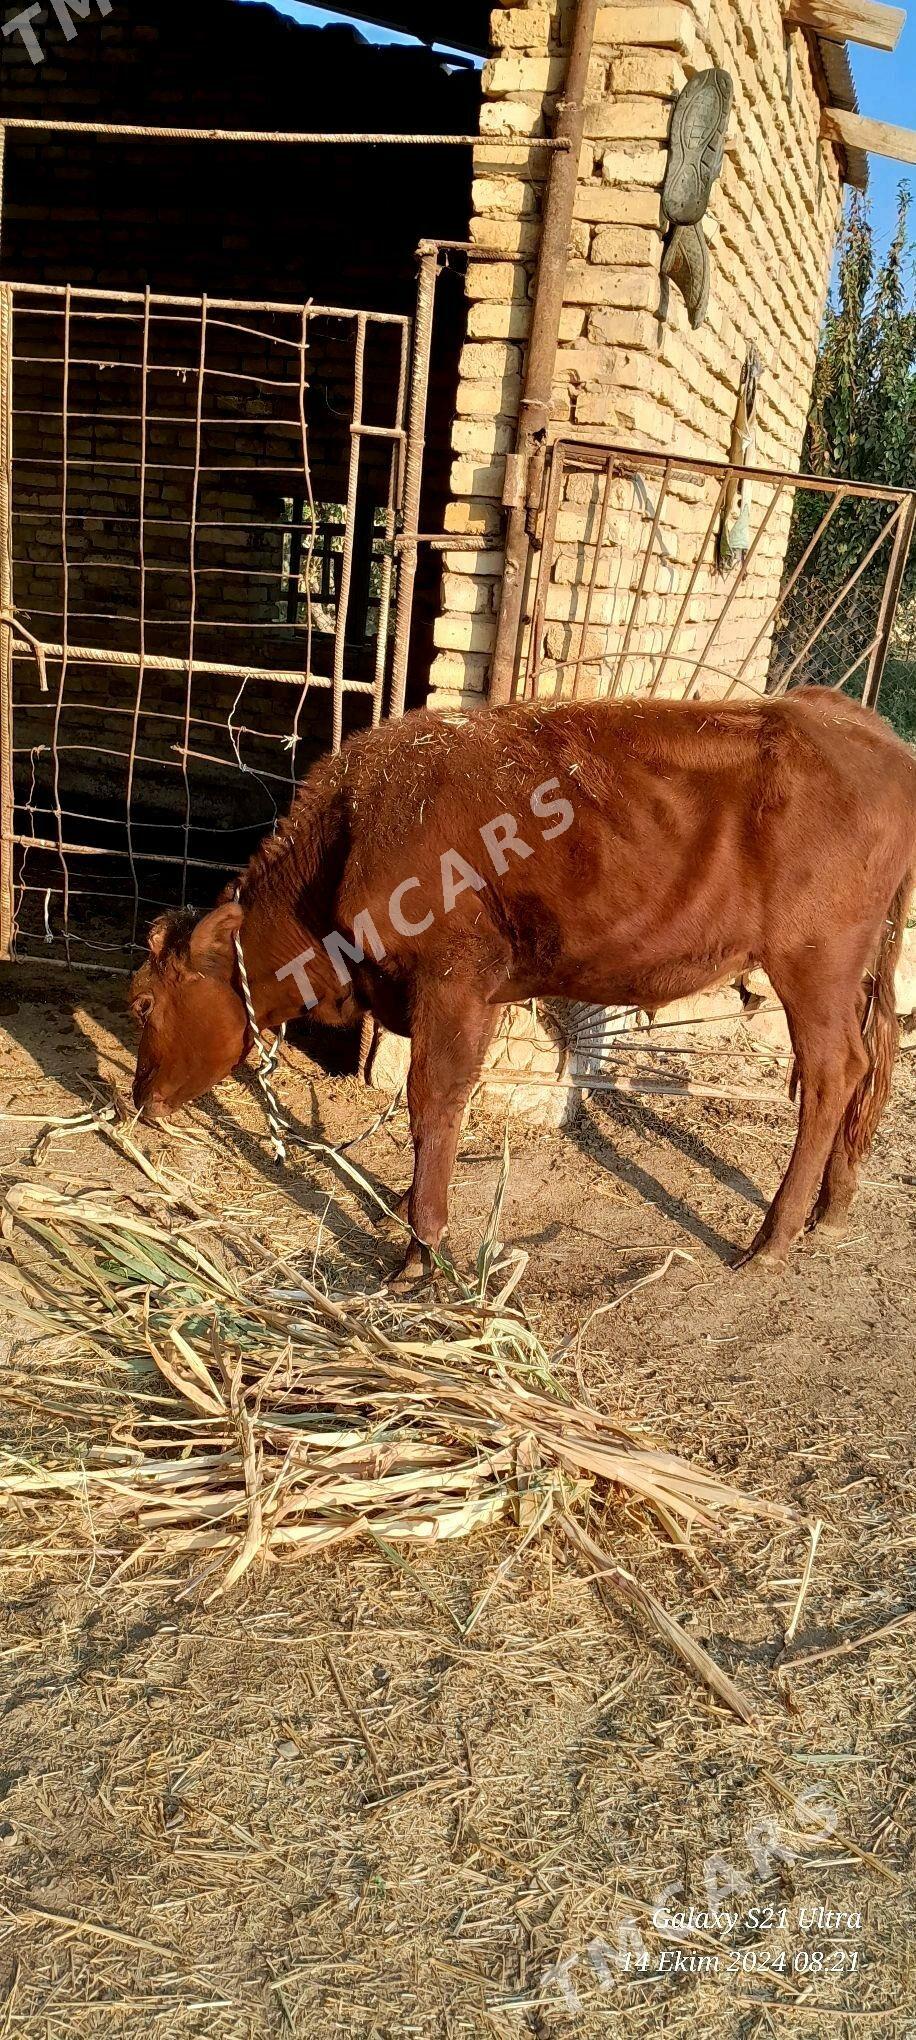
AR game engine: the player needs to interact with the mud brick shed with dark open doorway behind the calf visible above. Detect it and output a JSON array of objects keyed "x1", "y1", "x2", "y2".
[{"x1": 0, "y1": 0, "x2": 912, "y2": 961}]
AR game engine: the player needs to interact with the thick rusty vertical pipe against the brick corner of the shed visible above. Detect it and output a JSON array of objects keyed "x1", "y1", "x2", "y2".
[{"x1": 490, "y1": 0, "x2": 598, "y2": 704}]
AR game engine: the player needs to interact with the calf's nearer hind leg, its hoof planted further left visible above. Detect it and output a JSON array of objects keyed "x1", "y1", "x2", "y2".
[{"x1": 739, "y1": 975, "x2": 869, "y2": 1267}]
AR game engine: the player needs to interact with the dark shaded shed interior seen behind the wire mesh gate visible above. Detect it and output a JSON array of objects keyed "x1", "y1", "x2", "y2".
[{"x1": 0, "y1": 0, "x2": 479, "y2": 954}]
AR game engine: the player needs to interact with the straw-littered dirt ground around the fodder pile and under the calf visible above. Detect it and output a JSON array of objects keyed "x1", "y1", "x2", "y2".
[{"x1": 0, "y1": 969, "x2": 916, "y2": 2040}]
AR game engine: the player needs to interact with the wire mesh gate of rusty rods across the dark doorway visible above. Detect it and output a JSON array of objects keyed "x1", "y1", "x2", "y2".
[{"x1": 0, "y1": 284, "x2": 410, "y2": 967}]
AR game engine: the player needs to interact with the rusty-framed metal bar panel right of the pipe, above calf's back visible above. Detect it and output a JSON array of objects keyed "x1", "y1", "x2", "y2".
[{"x1": 522, "y1": 441, "x2": 914, "y2": 698}]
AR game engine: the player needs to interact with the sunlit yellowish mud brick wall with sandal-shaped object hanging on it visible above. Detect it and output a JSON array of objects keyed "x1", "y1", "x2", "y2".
[{"x1": 432, "y1": 0, "x2": 841, "y2": 704}]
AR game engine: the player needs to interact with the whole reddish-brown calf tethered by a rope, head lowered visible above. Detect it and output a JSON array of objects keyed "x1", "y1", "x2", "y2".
[{"x1": 133, "y1": 687, "x2": 916, "y2": 1271}]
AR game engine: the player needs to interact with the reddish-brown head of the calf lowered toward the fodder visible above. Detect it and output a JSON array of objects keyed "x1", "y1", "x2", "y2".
[{"x1": 131, "y1": 900, "x2": 251, "y2": 1120}]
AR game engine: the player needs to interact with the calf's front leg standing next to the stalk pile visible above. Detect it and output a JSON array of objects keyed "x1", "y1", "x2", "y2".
[{"x1": 402, "y1": 987, "x2": 498, "y2": 1277}]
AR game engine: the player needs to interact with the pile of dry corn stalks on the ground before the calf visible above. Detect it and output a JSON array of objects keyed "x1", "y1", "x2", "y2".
[{"x1": 0, "y1": 1181, "x2": 790, "y2": 1718}]
